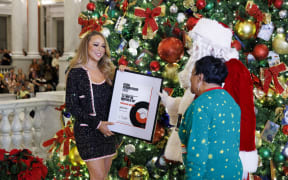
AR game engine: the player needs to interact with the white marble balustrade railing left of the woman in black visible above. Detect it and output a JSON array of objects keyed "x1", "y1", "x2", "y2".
[{"x1": 0, "y1": 91, "x2": 65, "y2": 156}]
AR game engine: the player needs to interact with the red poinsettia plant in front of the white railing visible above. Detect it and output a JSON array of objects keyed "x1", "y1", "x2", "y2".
[{"x1": 0, "y1": 149, "x2": 48, "y2": 180}]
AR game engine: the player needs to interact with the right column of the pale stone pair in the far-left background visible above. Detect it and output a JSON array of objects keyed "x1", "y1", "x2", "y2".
[{"x1": 28, "y1": 0, "x2": 40, "y2": 58}]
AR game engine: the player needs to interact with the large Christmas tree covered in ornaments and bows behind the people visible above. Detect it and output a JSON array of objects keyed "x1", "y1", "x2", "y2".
[{"x1": 44, "y1": 0, "x2": 288, "y2": 179}]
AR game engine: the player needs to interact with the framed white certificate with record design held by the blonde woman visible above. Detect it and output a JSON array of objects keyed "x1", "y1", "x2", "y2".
[{"x1": 108, "y1": 70, "x2": 163, "y2": 142}]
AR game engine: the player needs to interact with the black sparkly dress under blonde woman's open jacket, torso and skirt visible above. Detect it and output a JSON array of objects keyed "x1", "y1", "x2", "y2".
[{"x1": 74, "y1": 82, "x2": 116, "y2": 161}]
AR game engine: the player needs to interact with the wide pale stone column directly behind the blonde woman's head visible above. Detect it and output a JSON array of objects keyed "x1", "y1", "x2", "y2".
[{"x1": 57, "y1": 0, "x2": 89, "y2": 90}]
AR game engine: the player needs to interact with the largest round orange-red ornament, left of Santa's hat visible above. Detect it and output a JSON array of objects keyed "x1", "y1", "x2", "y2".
[{"x1": 158, "y1": 37, "x2": 184, "y2": 63}]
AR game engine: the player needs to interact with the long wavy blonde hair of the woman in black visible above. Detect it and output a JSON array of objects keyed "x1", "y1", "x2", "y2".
[{"x1": 67, "y1": 31, "x2": 115, "y2": 85}]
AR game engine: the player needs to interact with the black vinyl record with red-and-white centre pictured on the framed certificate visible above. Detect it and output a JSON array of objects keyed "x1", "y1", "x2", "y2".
[{"x1": 130, "y1": 101, "x2": 149, "y2": 128}]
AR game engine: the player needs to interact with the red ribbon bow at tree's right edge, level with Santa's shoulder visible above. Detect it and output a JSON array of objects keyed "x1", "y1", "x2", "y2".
[{"x1": 263, "y1": 63, "x2": 286, "y2": 94}]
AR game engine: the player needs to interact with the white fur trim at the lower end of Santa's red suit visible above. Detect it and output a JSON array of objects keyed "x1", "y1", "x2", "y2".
[{"x1": 239, "y1": 150, "x2": 258, "y2": 179}]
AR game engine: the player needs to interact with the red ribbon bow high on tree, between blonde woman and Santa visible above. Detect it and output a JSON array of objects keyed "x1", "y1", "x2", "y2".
[{"x1": 134, "y1": 7, "x2": 161, "y2": 36}]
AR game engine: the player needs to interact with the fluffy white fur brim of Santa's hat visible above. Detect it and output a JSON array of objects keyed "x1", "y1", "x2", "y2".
[{"x1": 189, "y1": 18, "x2": 233, "y2": 49}]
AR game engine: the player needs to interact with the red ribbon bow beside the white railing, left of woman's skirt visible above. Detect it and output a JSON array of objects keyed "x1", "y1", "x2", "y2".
[{"x1": 43, "y1": 122, "x2": 75, "y2": 156}]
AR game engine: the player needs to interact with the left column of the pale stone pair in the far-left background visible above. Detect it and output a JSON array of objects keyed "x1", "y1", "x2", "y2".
[{"x1": 11, "y1": 0, "x2": 26, "y2": 58}]
